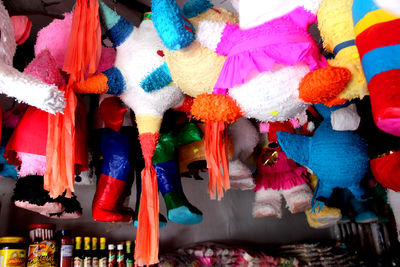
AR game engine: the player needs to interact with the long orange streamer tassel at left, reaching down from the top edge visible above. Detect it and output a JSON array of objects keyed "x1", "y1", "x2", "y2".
[{"x1": 44, "y1": 0, "x2": 101, "y2": 198}]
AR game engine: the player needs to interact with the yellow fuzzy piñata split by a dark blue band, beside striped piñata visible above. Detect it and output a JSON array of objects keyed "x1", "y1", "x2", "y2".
[{"x1": 317, "y1": 0, "x2": 368, "y2": 100}]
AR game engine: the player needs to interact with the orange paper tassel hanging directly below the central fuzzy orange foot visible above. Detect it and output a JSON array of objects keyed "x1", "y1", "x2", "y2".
[{"x1": 204, "y1": 121, "x2": 230, "y2": 200}]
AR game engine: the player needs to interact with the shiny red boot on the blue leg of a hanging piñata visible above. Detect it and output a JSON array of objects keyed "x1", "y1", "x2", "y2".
[{"x1": 92, "y1": 174, "x2": 132, "y2": 222}]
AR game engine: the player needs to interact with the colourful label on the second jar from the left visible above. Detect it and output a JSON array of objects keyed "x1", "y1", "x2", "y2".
[{"x1": 27, "y1": 240, "x2": 56, "y2": 267}]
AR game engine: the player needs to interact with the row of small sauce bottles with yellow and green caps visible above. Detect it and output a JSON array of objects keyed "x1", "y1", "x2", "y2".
[{"x1": 72, "y1": 236, "x2": 133, "y2": 267}]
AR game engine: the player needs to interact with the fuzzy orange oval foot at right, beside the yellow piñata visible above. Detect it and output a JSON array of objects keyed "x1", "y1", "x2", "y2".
[{"x1": 299, "y1": 66, "x2": 351, "y2": 104}]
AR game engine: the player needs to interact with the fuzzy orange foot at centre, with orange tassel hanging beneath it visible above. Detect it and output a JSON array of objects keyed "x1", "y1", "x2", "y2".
[{"x1": 192, "y1": 94, "x2": 242, "y2": 123}]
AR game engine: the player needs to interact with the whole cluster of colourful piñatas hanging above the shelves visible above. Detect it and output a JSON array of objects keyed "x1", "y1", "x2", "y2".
[{"x1": 0, "y1": 0, "x2": 400, "y2": 266}]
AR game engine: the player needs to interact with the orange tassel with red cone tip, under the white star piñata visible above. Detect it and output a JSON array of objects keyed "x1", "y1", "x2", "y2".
[{"x1": 135, "y1": 133, "x2": 159, "y2": 266}]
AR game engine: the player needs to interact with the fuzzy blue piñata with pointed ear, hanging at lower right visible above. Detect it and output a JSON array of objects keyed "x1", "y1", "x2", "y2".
[{"x1": 277, "y1": 104, "x2": 369, "y2": 208}]
